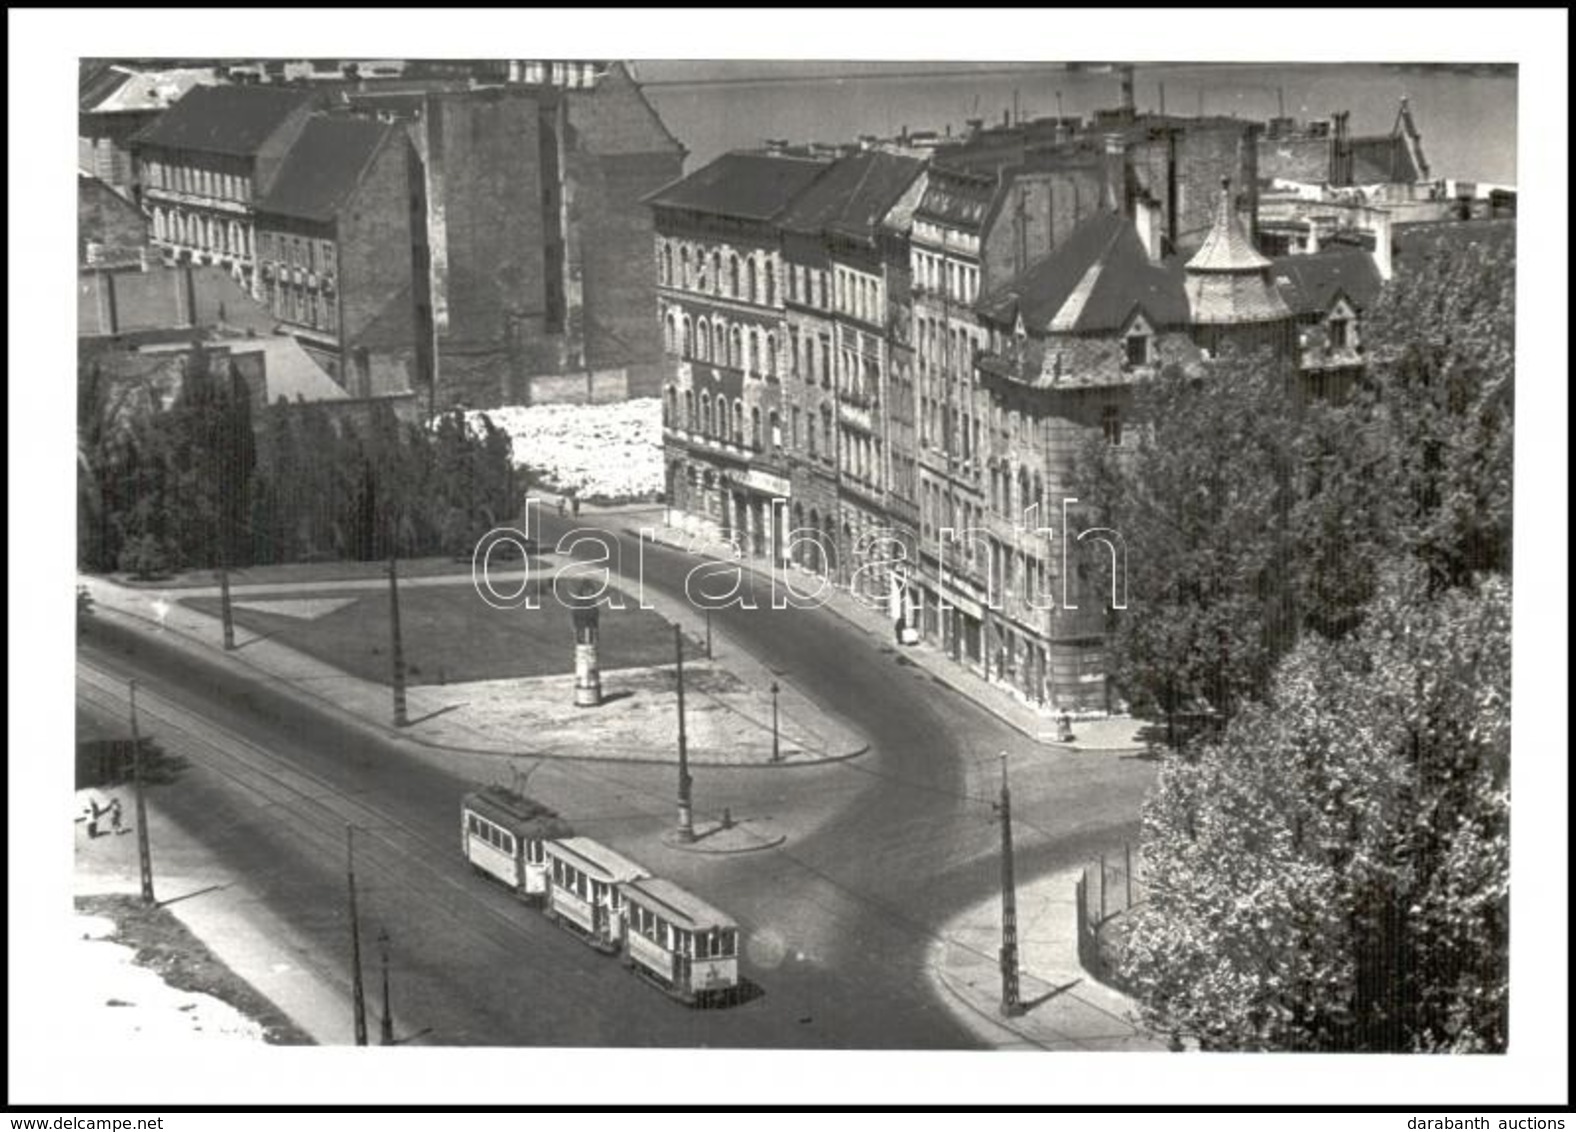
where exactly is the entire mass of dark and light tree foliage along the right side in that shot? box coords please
[1083,227,1515,1052]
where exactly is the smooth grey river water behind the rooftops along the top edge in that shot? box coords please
[635,60,1516,184]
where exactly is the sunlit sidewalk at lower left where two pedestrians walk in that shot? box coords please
[72,787,351,1044]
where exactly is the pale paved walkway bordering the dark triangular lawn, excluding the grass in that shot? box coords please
[79,557,867,766]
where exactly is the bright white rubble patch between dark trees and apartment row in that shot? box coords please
[468,397,662,501]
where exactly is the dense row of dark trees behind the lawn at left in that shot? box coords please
[77,350,520,577]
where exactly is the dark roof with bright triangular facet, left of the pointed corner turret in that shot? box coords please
[979,211,1188,334]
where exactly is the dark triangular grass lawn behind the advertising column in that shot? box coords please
[184,580,673,686]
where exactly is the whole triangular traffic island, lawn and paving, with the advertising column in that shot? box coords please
[82,560,865,768]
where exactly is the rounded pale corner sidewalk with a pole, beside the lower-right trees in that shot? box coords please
[927,869,1166,1052]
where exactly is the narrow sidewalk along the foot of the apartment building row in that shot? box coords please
[597,508,1149,754]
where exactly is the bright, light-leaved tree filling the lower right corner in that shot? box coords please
[1122,560,1510,1052]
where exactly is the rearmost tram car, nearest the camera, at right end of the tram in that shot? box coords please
[623,877,739,1006]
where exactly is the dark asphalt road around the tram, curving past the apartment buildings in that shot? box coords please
[79,522,1152,1048]
